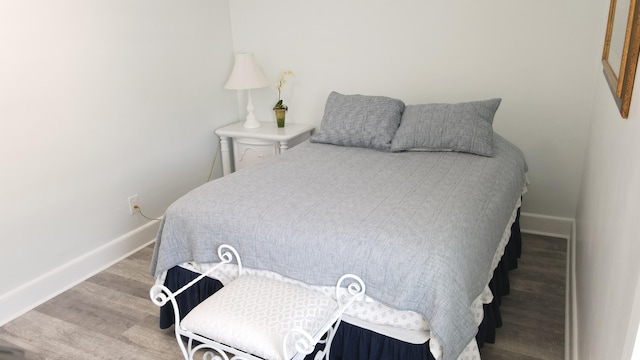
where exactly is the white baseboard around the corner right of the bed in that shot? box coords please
[520,212,577,360]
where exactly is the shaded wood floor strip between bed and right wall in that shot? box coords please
[480,234,567,360]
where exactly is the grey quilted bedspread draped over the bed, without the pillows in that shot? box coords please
[151,134,526,360]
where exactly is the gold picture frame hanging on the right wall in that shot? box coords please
[602,0,640,119]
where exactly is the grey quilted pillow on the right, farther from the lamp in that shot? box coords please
[391,99,502,156]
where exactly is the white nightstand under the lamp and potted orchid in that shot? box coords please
[215,122,314,175]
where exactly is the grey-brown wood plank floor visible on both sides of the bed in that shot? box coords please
[0,235,566,360]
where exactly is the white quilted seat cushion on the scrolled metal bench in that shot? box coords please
[181,275,338,360]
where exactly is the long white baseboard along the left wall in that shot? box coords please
[0,221,159,326]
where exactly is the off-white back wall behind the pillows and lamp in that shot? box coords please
[230,0,606,218]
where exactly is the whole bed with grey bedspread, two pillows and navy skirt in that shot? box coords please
[151,93,527,360]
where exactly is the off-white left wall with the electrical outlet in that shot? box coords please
[0,0,237,320]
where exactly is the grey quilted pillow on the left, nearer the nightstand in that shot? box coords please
[311,92,404,151]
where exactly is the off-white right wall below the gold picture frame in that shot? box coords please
[575,31,640,359]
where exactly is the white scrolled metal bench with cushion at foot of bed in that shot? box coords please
[150,245,365,360]
